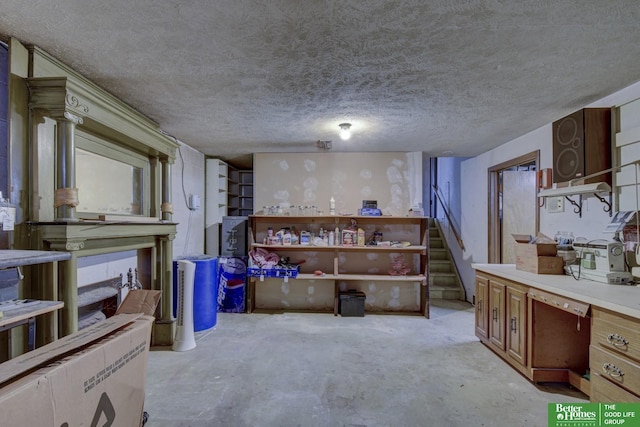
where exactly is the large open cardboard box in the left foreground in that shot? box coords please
[0,290,158,427]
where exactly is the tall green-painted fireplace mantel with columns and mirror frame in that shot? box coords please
[12,43,179,345]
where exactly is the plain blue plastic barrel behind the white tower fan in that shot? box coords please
[173,255,218,332]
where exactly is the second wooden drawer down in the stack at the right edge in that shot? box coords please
[589,345,640,394]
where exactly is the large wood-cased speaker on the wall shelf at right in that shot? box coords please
[552,108,611,184]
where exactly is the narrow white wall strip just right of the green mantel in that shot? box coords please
[171,143,205,259]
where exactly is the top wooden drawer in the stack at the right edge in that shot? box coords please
[591,310,640,361]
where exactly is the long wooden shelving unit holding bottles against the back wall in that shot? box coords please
[247,215,429,317]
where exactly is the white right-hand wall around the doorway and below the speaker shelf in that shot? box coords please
[456,82,640,299]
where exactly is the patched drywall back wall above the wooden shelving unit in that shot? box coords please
[253,152,423,216]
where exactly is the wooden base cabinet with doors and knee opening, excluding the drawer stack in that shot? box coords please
[475,273,590,394]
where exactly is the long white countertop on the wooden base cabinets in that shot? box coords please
[472,264,640,319]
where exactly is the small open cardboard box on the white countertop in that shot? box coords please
[514,235,564,274]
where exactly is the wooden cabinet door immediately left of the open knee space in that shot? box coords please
[506,286,527,366]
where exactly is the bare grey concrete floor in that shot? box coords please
[145,300,588,427]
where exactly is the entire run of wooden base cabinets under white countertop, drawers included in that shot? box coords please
[475,272,640,403]
